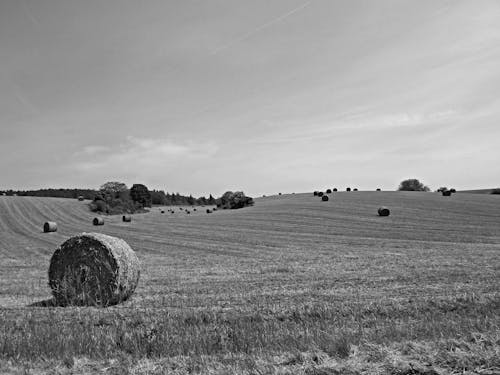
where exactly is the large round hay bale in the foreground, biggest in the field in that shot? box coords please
[49,233,140,306]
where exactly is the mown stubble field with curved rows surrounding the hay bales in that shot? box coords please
[0,192,500,375]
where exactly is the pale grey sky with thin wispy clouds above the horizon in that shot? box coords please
[0,0,500,196]
